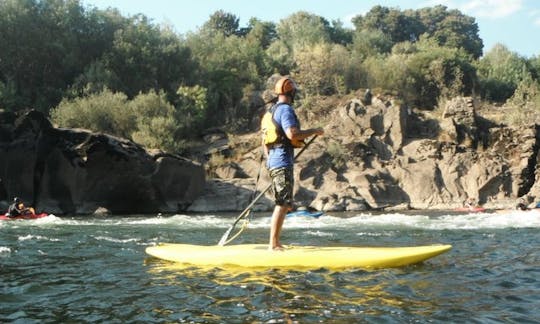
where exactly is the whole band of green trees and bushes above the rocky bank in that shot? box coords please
[0,0,540,152]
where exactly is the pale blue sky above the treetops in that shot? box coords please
[82,0,540,58]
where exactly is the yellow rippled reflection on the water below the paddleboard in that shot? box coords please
[146,259,436,322]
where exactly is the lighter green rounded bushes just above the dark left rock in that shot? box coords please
[51,86,202,152]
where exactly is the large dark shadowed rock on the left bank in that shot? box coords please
[0,111,205,214]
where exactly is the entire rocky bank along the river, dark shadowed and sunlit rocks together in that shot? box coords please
[0,96,540,214]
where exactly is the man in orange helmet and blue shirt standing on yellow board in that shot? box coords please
[261,77,324,250]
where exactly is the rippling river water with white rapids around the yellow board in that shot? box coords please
[0,211,540,323]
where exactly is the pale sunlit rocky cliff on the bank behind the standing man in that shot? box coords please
[188,96,540,212]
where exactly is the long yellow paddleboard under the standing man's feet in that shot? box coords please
[146,243,452,269]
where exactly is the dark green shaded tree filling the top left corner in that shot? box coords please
[0,0,116,111]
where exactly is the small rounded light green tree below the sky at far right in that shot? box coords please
[477,44,531,101]
